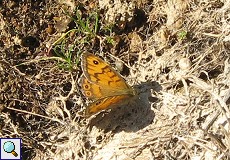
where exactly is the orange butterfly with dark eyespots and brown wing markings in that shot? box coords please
[80,52,136,116]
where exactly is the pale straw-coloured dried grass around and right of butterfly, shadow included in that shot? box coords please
[0,0,230,160]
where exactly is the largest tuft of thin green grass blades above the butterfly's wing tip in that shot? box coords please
[52,9,99,69]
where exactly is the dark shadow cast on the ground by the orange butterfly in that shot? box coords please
[89,82,162,133]
